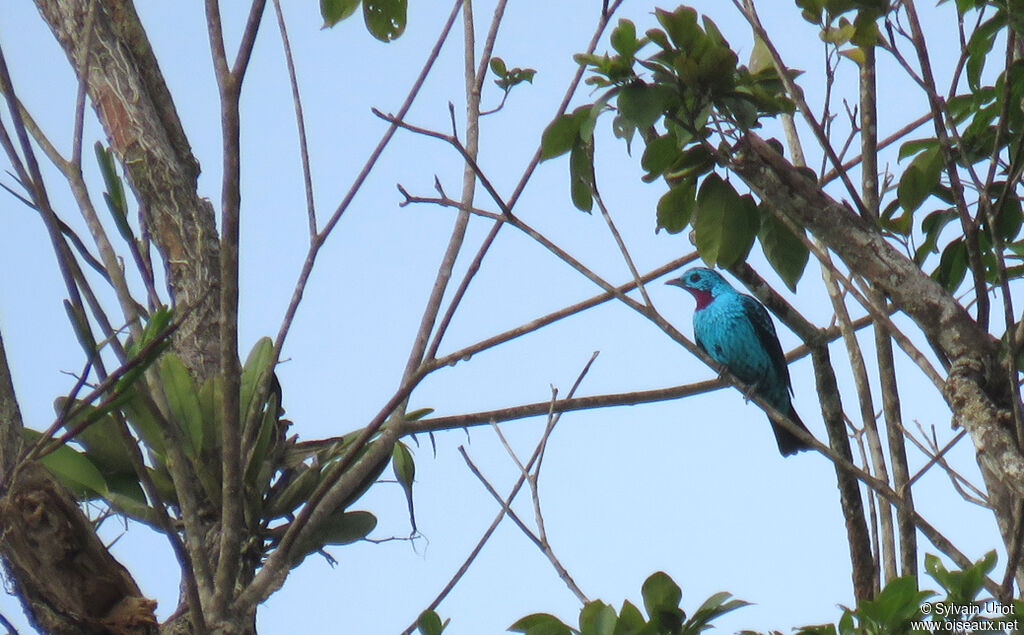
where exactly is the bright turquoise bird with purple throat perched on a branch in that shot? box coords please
[666,267,810,457]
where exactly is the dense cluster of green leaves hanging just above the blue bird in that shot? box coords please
[541,6,808,288]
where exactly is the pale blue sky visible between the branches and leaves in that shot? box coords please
[0,0,998,635]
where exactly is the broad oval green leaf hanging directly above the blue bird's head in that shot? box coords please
[693,173,759,268]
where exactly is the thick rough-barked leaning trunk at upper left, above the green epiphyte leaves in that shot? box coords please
[36,0,220,381]
